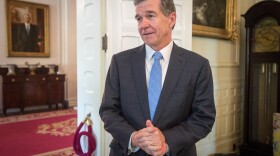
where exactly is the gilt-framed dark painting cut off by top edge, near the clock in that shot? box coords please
[192,0,237,40]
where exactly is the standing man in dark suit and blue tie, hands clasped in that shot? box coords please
[99,0,216,156]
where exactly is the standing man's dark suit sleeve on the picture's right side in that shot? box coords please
[163,61,216,156]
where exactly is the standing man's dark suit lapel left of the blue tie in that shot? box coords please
[131,45,150,119]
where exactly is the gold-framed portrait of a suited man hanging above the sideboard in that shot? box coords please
[6,0,50,57]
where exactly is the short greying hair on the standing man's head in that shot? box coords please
[134,0,176,16]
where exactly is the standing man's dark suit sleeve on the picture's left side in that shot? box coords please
[99,55,135,155]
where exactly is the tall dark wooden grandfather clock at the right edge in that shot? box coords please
[240,0,280,156]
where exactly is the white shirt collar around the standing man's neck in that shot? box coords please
[145,41,173,62]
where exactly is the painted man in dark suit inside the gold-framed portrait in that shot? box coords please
[17,14,39,52]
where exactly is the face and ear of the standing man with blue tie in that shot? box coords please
[135,0,176,50]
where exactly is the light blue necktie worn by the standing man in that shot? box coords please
[148,52,162,120]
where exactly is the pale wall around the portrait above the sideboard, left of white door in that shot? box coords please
[0,0,77,110]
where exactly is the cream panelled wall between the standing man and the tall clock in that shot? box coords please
[192,0,260,155]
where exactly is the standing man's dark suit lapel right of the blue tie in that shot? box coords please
[153,43,185,124]
